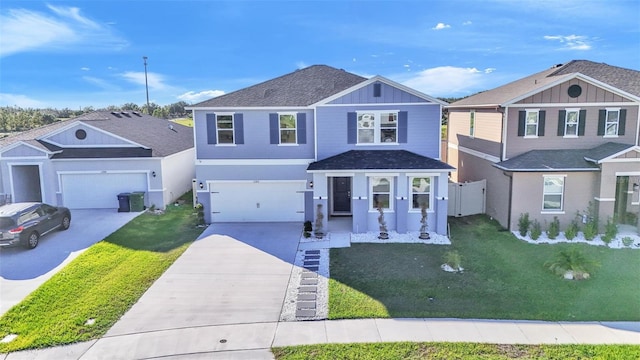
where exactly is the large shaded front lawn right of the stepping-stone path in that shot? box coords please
[329,216,640,321]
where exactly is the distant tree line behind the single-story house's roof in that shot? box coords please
[0,101,189,133]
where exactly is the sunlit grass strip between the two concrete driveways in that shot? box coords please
[0,194,202,353]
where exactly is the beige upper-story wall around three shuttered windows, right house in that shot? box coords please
[506,106,638,158]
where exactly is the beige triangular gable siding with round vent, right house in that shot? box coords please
[517,79,631,104]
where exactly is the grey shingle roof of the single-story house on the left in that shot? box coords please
[0,111,194,157]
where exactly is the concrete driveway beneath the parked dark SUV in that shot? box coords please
[0,209,142,315]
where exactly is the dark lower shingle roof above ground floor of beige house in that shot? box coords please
[494,143,633,172]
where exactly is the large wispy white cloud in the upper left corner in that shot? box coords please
[0,5,127,57]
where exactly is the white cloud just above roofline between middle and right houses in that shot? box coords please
[402,66,495,97]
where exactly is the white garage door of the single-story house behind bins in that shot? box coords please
[62,173,147,209]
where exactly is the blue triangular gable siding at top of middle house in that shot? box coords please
[329,82,427,104]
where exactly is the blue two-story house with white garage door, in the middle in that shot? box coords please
[189,65,453,234]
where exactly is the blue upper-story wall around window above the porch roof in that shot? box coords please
[316,104,440,160]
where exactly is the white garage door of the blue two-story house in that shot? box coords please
[211,181,305,222]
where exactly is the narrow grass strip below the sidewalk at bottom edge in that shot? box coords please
[272,342,640,360]
